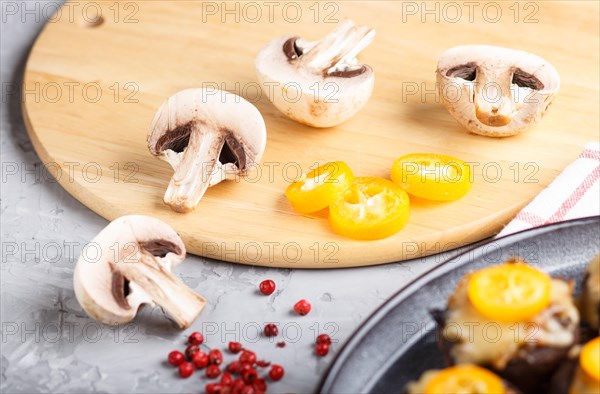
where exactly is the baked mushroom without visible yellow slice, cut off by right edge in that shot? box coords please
[579,255,600,335]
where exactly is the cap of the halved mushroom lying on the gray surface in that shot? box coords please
[73,215,186,324]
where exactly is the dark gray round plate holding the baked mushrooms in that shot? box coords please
[318,217,600,394]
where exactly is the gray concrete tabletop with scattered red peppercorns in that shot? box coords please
[0,3,464,393]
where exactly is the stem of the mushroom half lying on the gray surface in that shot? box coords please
[116,250,206,329]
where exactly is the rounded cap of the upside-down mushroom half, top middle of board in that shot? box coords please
[255,36,375,127]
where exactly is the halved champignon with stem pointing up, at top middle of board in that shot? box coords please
[255,20,375,127]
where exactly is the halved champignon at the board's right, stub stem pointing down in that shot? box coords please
[437,45,560,137]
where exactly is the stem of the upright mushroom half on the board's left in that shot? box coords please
[164,121,224,212]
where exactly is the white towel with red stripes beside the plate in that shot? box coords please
[498,142,600,237]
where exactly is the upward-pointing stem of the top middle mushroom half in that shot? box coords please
[300,19,375,72]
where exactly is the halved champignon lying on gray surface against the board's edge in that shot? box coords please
[73,215,206,328]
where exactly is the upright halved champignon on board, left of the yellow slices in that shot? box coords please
[148,89,267,212]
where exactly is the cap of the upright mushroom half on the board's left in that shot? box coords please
[148,88,267,167]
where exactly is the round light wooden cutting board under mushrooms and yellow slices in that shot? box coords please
[23,0,600,268]
